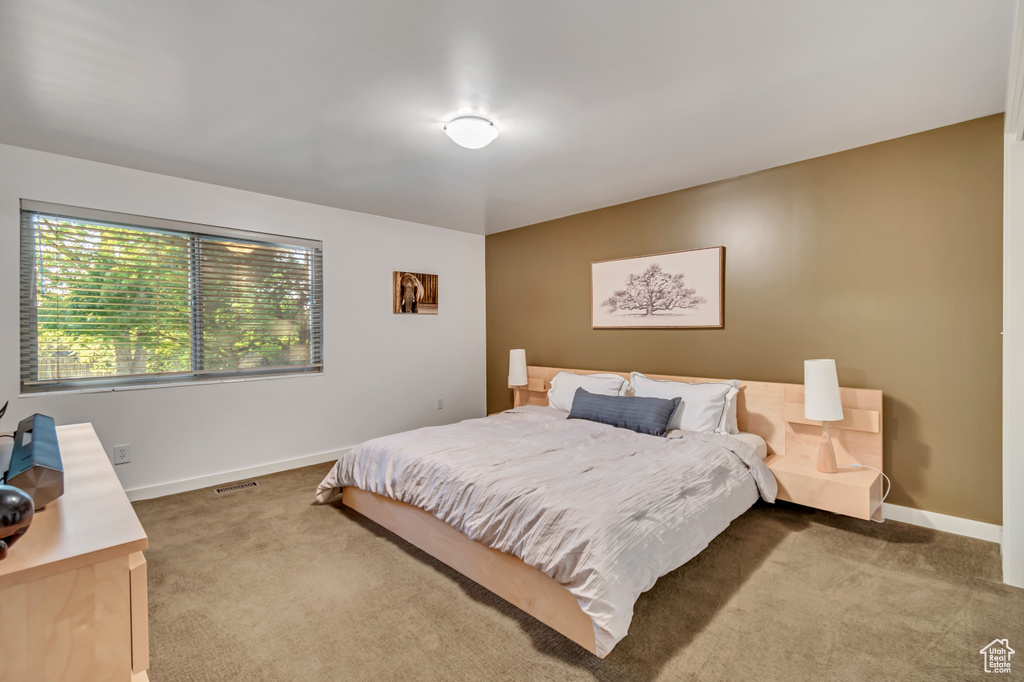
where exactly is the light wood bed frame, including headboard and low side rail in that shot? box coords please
[342,367,882,654]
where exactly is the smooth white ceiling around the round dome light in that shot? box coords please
[0,0,1016,233]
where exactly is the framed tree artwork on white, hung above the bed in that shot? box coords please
[591,247,725,329]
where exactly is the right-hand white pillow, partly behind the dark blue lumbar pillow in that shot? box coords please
[630,372,739,434]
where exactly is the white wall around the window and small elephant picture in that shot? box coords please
[0,144,485,495]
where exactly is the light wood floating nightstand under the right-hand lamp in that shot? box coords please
[765,455,883,521]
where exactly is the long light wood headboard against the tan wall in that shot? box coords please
[514,366,882,469]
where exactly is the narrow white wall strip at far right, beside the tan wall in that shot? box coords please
[1002,134,1024,587]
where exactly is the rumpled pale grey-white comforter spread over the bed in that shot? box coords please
[316,409,776,656]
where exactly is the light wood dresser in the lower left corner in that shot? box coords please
[0,424,150,682]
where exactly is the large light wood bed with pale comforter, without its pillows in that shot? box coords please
[317,367,884,657]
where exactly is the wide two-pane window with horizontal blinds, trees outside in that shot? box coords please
[22,200,323,392]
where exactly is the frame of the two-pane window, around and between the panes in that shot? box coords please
[18,199,324,395]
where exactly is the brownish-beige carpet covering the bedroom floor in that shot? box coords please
[135,464,1024,682]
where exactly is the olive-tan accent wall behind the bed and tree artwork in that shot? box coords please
[486,115,1002,523]
